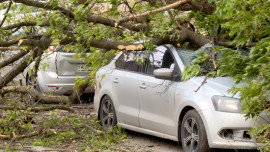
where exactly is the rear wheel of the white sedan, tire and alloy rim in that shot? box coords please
[99,96,117,131]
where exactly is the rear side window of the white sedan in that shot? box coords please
[115,51,147,73]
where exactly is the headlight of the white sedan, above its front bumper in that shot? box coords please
[212,96,241,113]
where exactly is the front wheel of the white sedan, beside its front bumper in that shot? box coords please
[181,110,211,152]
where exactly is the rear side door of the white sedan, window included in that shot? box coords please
[112,51,148,127]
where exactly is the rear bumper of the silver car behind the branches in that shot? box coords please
[37,71,94,95]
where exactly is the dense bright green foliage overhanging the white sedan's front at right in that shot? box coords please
[190,0,270,151]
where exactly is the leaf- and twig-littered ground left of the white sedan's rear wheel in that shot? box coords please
[0,94,126,151]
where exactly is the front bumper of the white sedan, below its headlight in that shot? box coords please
[199,111,265,149]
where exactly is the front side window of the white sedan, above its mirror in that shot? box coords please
[146,46,175,75]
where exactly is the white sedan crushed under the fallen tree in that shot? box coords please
[94,45,262,152]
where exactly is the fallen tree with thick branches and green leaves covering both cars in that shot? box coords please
[0,0,270,150]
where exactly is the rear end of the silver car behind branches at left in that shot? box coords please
[37,52,94,94]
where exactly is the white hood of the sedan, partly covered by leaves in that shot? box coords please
[191,77,244,98]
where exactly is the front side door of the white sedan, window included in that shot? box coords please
[139,46,180,135]
